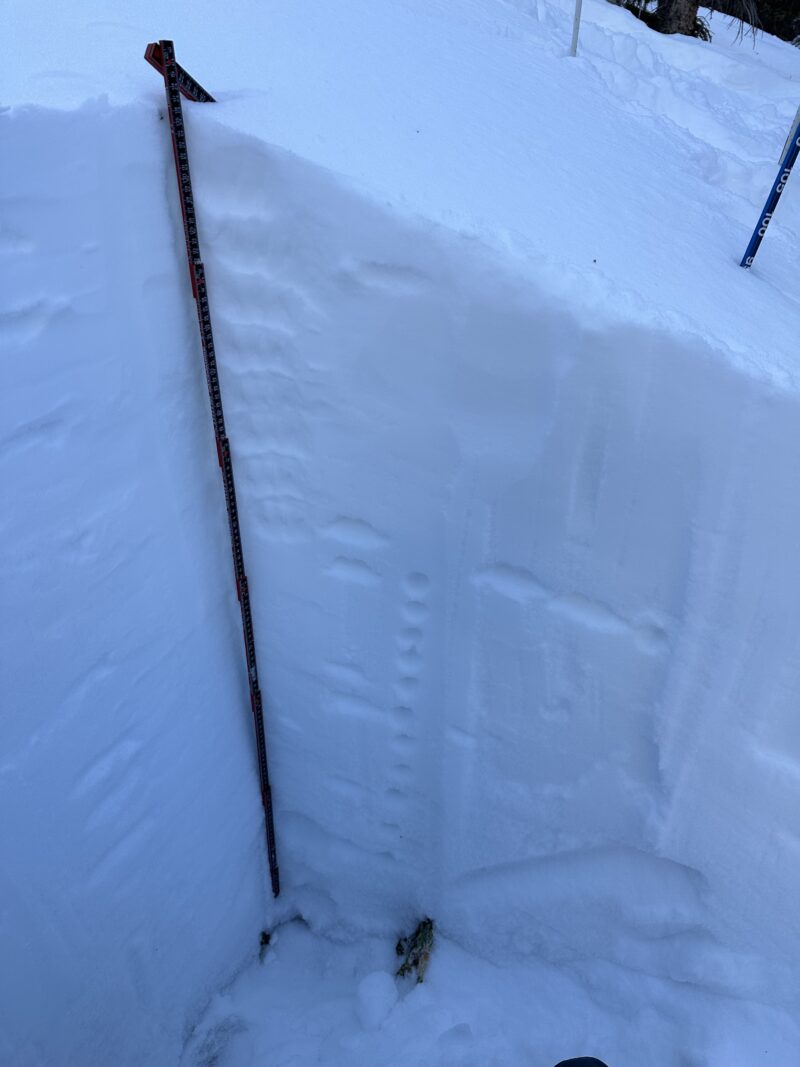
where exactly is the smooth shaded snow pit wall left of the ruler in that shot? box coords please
[0,106,275,1067]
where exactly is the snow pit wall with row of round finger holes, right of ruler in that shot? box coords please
[190,122,800,1003]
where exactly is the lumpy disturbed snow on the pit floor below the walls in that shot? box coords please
[181,922,800,1067]
